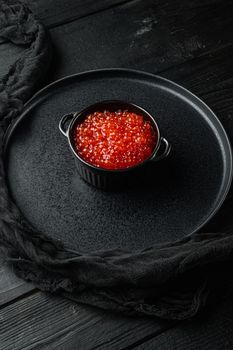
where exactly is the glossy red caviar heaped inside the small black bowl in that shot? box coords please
[74,110,156,169]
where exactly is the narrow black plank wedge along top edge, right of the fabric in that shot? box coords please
[28,0,134,28]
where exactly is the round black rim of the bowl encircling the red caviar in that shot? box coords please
[66,100,161,173]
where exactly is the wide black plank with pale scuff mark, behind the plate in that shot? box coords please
[45,0,233,81]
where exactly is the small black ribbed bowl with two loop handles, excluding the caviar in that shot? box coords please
[59,101,171,190]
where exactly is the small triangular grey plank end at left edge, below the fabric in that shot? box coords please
[0,254,35,307]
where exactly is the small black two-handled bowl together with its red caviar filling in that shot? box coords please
[59,101,171,189]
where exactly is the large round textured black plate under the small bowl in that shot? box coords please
[3,69,232,251]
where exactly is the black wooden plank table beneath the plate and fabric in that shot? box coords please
[0,0,233,350]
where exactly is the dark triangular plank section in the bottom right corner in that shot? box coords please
[134,300,233,350]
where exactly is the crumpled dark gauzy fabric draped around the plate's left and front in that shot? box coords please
[0,0,233,320]
